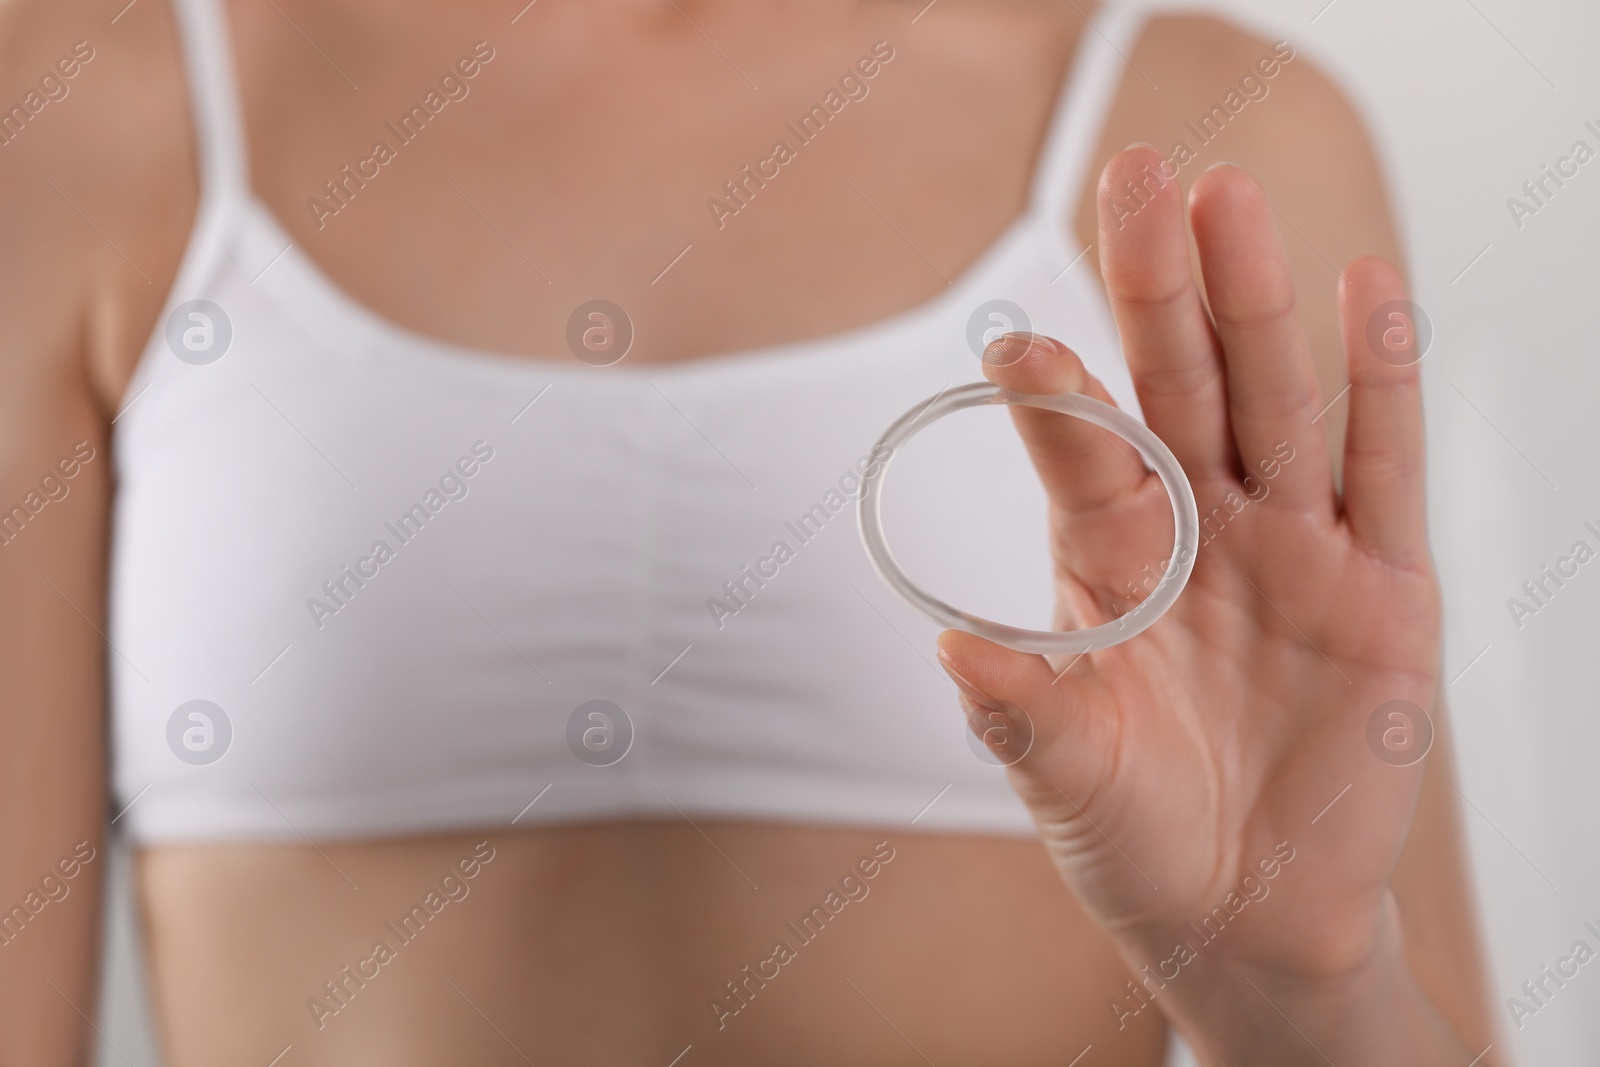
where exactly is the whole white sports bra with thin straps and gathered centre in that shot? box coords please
[109,0,1139,843]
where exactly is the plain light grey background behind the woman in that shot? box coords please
[98,0,1600,1067]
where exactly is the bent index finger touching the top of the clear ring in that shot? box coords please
[984,333,1147,514]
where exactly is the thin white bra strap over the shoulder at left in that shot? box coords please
[173,0,250,198]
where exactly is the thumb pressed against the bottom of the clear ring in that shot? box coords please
[938,630,1117,812]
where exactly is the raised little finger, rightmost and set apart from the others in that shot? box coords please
[1339,256,1427,565]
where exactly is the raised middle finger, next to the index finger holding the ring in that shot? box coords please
[1099,147,1235,480]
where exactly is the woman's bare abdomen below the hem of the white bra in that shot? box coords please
[139,821,1165,1067]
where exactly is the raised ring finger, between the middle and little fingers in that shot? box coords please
[1190,166,1334,520]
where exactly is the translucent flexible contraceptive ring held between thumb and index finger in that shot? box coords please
[858,382,1200,656]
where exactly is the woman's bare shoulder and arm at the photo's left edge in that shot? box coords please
[0,2,194,1067]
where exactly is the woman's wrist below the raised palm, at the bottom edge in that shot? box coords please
[1128,901,1472,1067]
